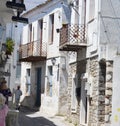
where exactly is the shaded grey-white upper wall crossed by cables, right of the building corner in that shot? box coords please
[100,0,120,60]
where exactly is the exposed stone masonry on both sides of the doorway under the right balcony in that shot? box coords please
[68,57,113,126]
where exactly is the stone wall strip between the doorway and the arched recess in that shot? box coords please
[88,57,99,126]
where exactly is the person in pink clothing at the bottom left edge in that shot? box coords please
[0,93,9,126]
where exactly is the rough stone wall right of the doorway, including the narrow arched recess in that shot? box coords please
[88,58,113,126]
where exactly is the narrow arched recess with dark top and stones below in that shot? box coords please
[98,59,106,126]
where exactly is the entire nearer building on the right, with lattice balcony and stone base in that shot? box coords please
[60,0,120,126]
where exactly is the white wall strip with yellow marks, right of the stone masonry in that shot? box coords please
[111,55,120,126]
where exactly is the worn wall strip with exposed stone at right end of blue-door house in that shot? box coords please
[56,56,68,115]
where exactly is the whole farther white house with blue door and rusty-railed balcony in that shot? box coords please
[20,0,70,115]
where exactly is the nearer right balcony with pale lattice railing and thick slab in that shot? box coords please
[59,24,87,51]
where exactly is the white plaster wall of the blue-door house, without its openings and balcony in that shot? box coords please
[21,0,69,114]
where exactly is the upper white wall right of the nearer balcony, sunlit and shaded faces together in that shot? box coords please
[86,0,120,60]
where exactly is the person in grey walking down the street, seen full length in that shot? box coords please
[15,86,22,110]
